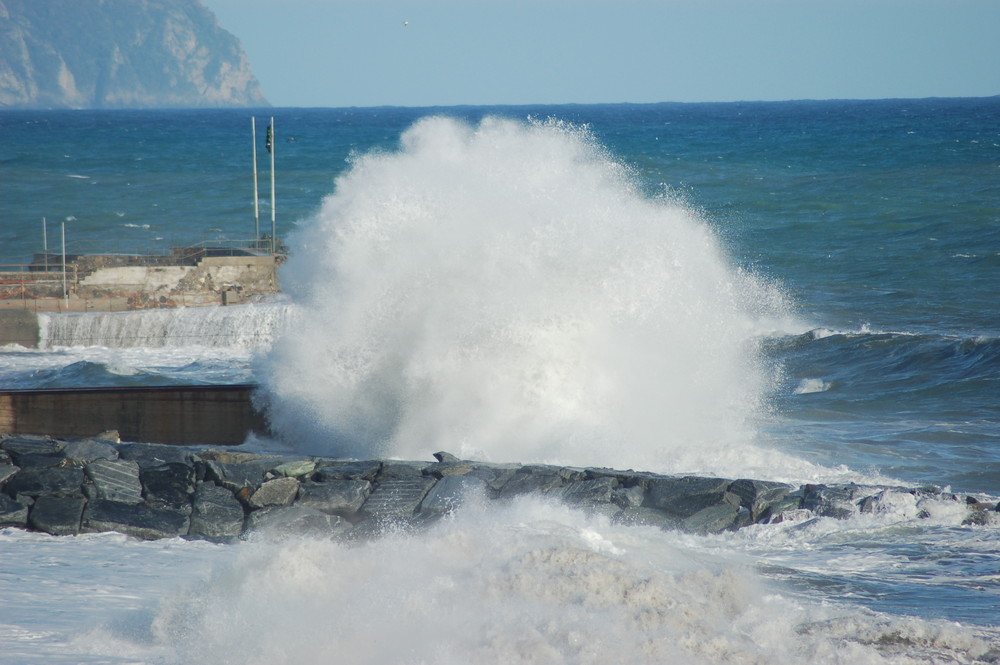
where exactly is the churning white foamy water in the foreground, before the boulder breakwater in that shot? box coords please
[0,499,995,665]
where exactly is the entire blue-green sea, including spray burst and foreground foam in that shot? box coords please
[0,97,1000,665]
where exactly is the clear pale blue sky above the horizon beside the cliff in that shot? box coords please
[202,0,1000,107]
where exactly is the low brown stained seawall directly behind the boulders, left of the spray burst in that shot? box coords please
[0,385,265,445]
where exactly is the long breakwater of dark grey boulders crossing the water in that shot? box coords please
[0,434,1000,542]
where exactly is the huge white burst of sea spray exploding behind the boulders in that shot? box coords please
[257,117,796,472]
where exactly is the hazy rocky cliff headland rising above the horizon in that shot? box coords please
[0,0,267,109]
